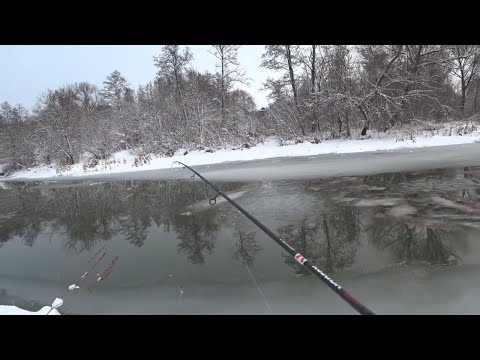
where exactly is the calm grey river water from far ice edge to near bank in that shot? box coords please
[0,167,480,314]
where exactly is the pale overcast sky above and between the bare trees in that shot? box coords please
[0,45,271,108]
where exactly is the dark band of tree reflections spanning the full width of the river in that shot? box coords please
[0,168,480,274]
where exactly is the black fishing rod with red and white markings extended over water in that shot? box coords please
[173,161,375,315]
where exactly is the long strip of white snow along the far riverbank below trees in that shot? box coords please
[0,130,480,183]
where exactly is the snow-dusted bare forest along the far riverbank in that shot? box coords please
[0,45,480,174]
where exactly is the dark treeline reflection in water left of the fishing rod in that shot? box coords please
[0,181,239,253]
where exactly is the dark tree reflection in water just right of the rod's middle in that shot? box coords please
[279,206,360,274]
